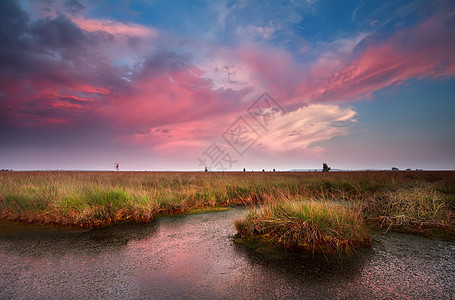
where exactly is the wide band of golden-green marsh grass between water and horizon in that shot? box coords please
[0,171,455,229]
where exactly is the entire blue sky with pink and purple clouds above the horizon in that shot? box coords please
[0,0,455,171]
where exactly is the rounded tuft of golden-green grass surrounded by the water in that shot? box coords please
[235,200,371,254]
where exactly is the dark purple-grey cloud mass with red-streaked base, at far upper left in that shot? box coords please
[0,1,127,126]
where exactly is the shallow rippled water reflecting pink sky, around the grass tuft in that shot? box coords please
[0,209,455,299]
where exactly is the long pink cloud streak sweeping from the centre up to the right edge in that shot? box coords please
[230,13,455,105]
